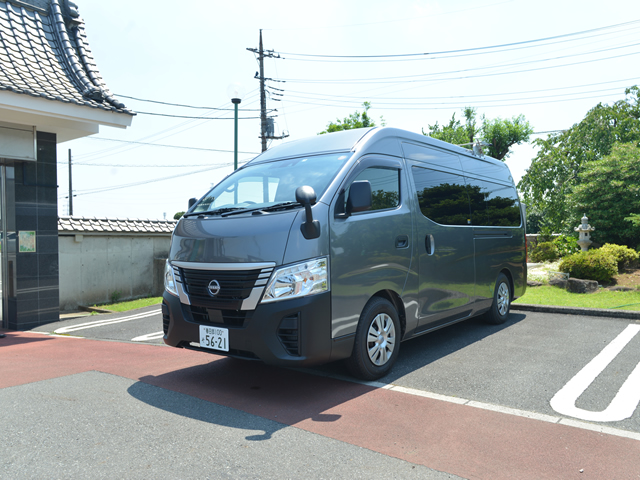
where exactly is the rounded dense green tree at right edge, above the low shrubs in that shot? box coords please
[569,143,640,248]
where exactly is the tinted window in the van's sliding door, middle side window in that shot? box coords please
[411,167,471,225]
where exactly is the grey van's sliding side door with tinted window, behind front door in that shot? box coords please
[411,165,475,330]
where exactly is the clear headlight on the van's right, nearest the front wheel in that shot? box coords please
[262,257,329,303]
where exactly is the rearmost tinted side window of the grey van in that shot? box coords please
[467,177,520,227]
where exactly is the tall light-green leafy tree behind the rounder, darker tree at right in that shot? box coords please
[518,86,640,232]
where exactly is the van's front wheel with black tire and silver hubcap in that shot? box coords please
[346,297,401,380]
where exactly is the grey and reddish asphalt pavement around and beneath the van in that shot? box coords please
[0,307,640,480]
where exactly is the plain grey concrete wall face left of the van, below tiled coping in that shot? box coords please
[58,234,171,311]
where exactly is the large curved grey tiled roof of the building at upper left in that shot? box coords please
[0,0,134,115]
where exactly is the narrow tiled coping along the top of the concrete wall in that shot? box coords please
[58,217,178,235]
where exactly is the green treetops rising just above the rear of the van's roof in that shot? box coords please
[422,107,533,161]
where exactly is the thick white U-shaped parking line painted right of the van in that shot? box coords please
[551,324,640,422]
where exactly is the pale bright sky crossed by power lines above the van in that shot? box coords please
[58,0,640,219]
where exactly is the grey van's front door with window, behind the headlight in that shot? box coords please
[329,157,412,338]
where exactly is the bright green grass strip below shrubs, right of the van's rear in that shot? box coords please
[514,285,640,311]
